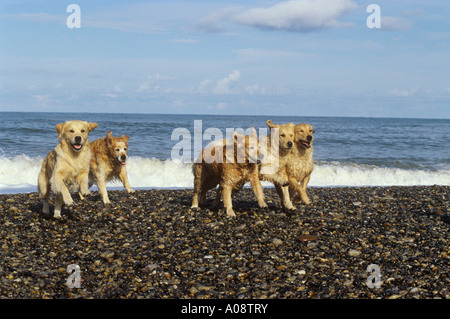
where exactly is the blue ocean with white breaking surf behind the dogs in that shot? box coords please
[0,112,450,193]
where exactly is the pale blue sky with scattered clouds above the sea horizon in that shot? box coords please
[0,0,450,119]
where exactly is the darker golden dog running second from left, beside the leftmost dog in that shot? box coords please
[80,131,134,204]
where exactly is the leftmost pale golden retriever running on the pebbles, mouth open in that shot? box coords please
[38,120,98,218]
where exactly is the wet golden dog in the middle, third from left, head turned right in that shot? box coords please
[191,127,267,217]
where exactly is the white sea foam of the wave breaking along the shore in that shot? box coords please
[0,155,450,193]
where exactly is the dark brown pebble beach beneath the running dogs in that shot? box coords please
[0,186,450,299]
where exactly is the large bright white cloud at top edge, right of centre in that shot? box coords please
[233,0,358,32]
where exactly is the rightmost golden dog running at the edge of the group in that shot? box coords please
[286,124,314,204]
